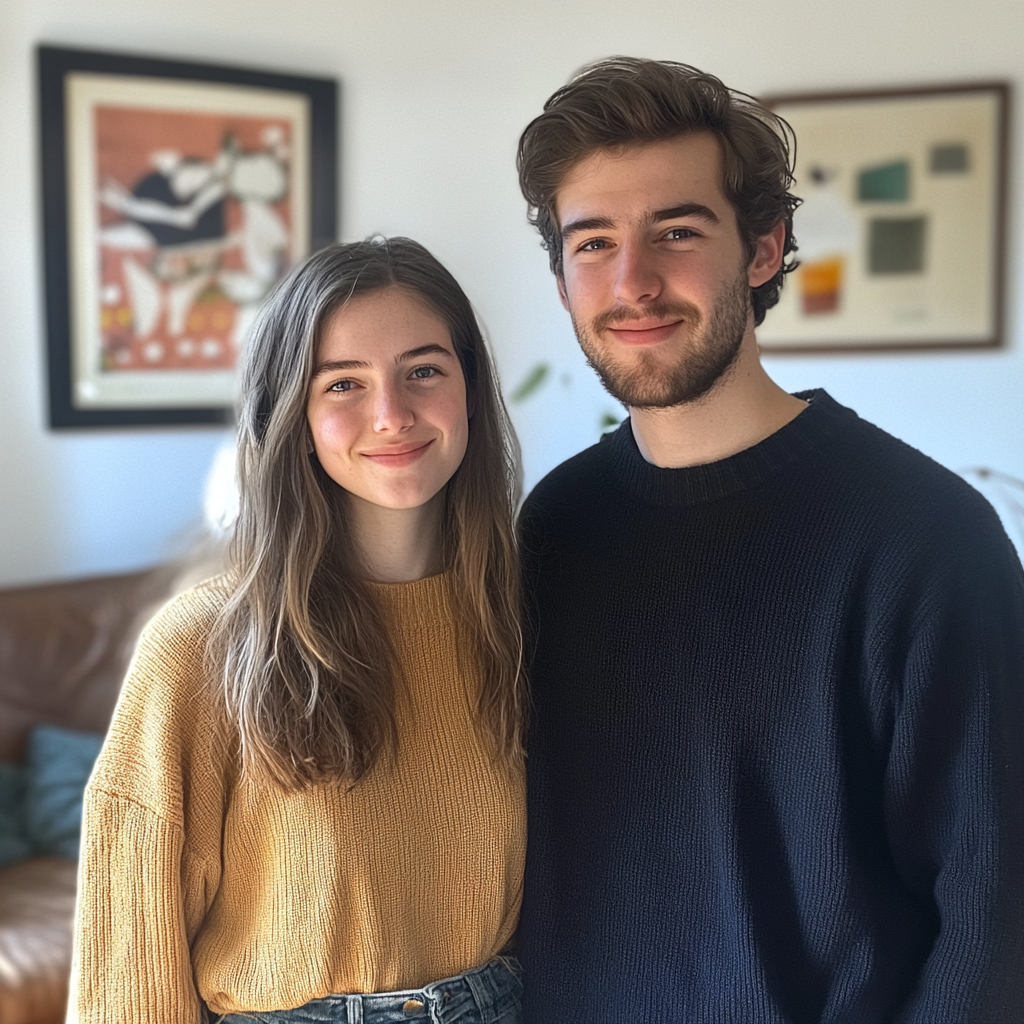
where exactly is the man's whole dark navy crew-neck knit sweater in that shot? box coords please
[519,391,1024,1024]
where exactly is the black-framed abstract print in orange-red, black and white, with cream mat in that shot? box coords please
[38,46,338,427]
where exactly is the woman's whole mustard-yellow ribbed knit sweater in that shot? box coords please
[71,574,525,1024]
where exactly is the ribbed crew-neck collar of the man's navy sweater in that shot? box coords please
[604,388,857,505]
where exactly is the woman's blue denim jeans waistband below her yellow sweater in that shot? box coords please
[215,961,522,1024]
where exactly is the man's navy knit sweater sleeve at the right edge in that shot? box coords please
[886,510,1024,1024]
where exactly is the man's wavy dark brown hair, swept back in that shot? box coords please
[517,56,800,324]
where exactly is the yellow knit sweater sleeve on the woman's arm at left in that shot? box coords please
[69,587,226,1024]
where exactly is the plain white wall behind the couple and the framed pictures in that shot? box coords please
[0,0,1024,584]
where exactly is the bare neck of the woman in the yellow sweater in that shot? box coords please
[348,494,444,583]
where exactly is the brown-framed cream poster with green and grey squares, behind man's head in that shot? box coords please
[758,83,1010,352]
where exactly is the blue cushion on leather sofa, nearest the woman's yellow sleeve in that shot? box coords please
[25,725,103,858]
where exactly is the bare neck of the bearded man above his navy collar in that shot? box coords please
[630,333,807,469]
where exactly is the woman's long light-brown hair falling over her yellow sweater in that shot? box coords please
[207,237,525,790]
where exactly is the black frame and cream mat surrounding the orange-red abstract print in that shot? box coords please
[37,45,339,429]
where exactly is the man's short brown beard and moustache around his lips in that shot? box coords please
[570,269,751,409]
